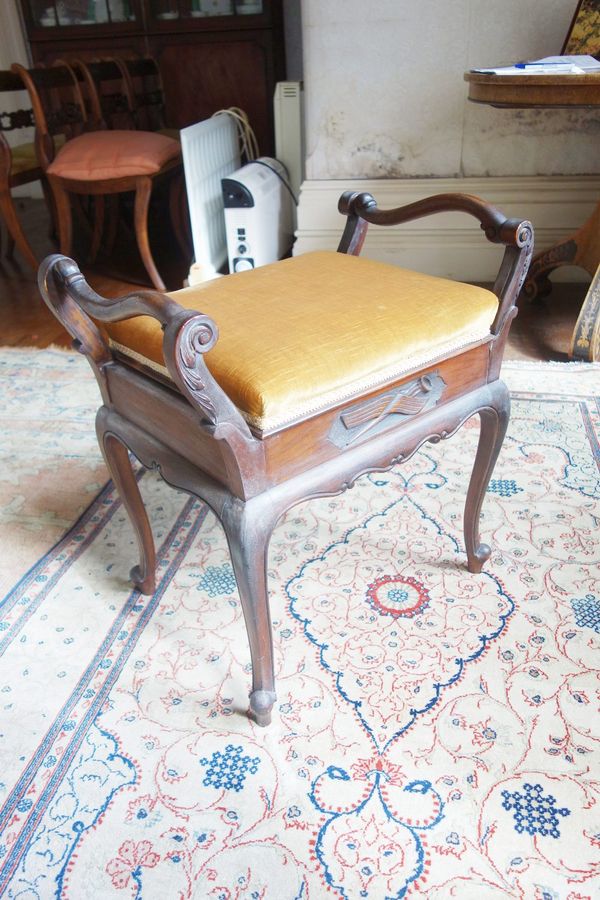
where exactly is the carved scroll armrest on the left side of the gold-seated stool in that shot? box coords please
[38,254,256,443]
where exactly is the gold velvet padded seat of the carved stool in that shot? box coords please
[106,251,498,432]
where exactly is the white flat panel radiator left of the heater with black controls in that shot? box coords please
[181,115,240,284]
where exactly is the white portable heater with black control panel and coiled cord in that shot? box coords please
[221,156,294,272]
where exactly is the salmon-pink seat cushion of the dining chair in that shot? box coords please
[48,130,181,181]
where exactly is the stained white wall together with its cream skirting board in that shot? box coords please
[294,0,600,281]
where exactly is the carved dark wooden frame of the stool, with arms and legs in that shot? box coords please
[39,193,533,725]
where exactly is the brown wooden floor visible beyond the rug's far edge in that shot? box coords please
[0,200,587,361]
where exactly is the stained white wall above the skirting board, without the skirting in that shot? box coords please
[302,0,600,179]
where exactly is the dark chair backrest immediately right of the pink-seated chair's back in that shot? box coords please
[70,59,136,129]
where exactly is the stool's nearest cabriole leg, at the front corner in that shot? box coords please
[221,499,277,726]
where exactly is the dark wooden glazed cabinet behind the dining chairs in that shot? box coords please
[20,0,285,153]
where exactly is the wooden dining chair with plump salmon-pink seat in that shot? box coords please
[12,63,182,290]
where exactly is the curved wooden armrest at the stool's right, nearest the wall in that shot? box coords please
[338,191,533,334]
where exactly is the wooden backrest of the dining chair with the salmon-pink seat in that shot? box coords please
[11,63,88,171]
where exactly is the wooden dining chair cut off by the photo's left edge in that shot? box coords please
[0,71,42,271]
